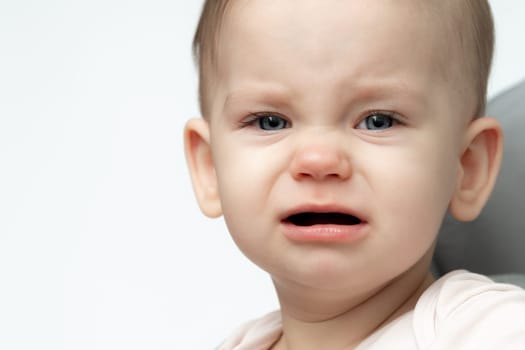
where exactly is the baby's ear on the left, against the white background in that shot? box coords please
[184,119,222,217]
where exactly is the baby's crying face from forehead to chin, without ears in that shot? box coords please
[205,0,467,290]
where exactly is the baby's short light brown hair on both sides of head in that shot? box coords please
[193,0,494,118]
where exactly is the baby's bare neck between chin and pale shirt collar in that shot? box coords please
[272,258,434,350]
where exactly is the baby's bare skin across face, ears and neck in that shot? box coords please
[185,0,502,350]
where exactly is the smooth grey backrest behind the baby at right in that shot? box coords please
[433,81,525,287]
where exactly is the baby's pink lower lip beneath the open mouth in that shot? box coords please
[283,222,366,242]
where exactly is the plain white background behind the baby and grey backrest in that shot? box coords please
[0,0,525,350]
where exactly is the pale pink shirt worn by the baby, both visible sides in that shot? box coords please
[219,271,525,350]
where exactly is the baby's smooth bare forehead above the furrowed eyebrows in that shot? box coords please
[219,0,450,101]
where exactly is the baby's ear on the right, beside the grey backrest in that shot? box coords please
[450,117,503,221]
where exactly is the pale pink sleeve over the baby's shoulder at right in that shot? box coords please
[413,271,525,349]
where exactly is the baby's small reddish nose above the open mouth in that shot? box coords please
[290,140,352,181]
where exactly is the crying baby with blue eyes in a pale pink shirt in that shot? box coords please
[185,0,525,350]
